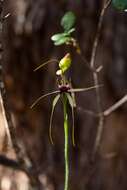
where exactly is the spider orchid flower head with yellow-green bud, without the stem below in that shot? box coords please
[31,53,100,146]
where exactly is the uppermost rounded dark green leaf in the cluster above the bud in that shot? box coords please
[61,11,76,31]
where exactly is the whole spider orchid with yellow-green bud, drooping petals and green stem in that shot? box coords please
[31,53,101,190]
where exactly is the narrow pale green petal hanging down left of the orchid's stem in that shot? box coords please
[49,94,60,144]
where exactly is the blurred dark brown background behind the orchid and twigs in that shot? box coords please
[0,0,127,190]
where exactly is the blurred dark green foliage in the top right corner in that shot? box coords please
[112,0,127,11]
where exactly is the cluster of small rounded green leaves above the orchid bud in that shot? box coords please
[51,11,76,46]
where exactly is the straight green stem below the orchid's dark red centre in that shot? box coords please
[63,94,69,190]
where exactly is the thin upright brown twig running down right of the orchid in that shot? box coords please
[90,0,111,155]
